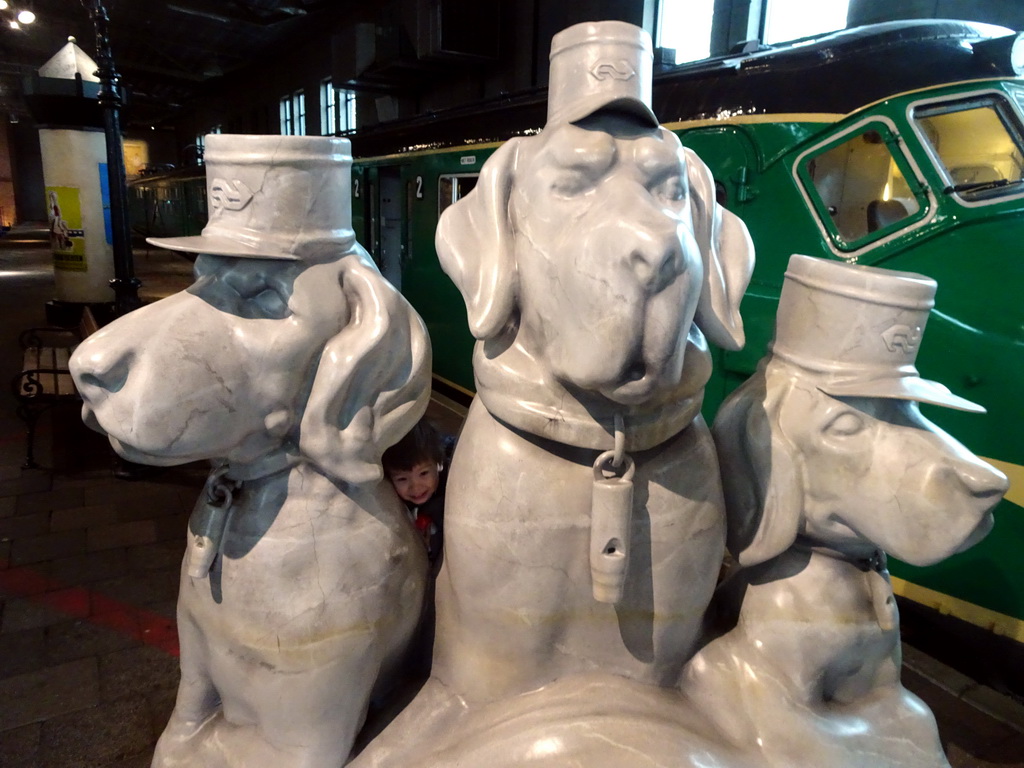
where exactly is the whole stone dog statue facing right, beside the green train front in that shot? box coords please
[683,255,1007,768]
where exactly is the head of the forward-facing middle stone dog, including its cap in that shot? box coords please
[436,23,753,404]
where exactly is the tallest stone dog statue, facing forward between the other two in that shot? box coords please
[353,22,753,768]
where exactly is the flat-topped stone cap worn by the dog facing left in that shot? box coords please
[147,134,355,261]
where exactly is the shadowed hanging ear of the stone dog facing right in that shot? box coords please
[712,361,804,566]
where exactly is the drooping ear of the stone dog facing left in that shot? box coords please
[299,249,430,484]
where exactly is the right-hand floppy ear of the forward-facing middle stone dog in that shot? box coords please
[683,147,754,349]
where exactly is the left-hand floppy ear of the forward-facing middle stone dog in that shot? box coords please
[434,138,522,339]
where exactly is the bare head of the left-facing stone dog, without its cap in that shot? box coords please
[72,247,429,482]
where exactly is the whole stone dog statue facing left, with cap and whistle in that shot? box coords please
[72,135,430,768]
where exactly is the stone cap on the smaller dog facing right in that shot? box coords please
[771,254,985,413]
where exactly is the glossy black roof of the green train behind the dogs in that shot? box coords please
[349,19,1024,158]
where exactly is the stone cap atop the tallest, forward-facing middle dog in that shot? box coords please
[548,22,657,126]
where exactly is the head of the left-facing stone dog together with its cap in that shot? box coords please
[71,136,430,483]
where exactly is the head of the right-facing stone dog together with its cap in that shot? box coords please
[713,256,1008,566]
